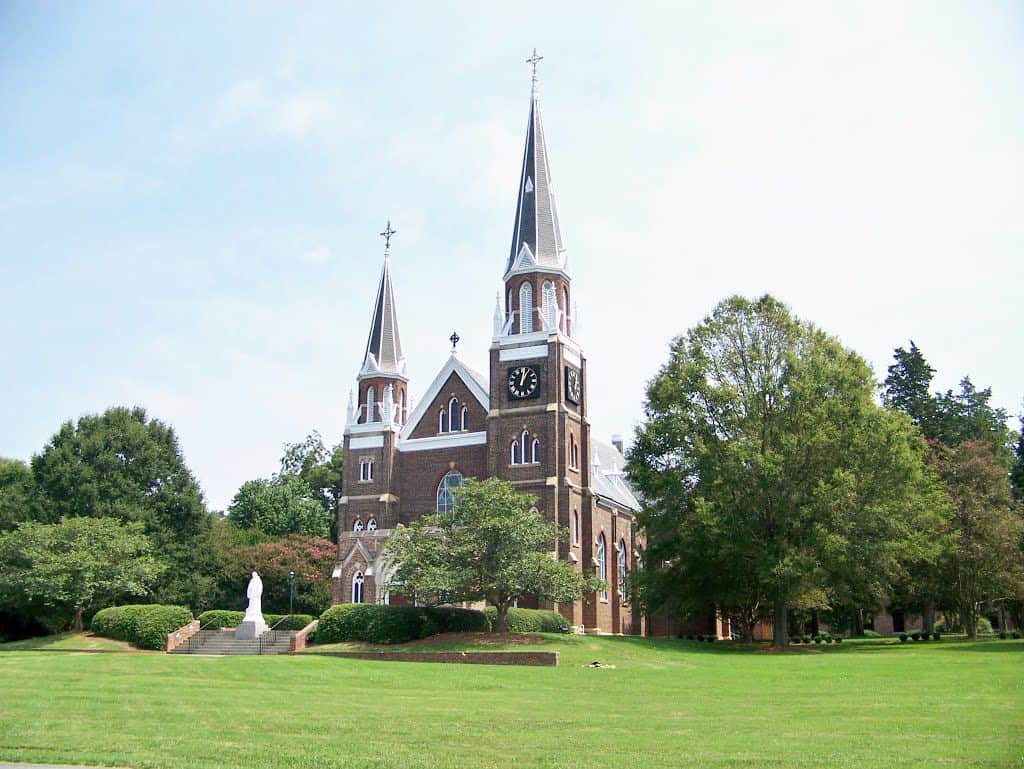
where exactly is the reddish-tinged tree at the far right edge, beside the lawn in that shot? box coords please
[934,440,1024,638]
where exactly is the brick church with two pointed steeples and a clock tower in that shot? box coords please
[332,57,644,634]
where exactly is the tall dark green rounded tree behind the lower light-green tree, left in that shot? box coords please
[31,407,213,606]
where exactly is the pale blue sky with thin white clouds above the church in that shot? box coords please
[0,0,1024,509]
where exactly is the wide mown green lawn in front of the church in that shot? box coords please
[0,636,1024,769]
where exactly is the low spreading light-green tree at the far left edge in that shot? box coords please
[0,517,162,631]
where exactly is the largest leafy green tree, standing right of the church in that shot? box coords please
[629,296,931,645]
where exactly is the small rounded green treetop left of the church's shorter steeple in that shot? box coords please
[227,474,333,538]
